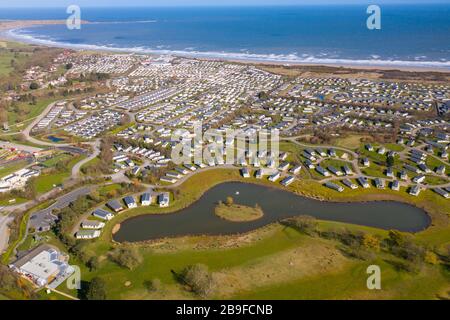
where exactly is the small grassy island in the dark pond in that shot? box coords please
[214,197,264,222]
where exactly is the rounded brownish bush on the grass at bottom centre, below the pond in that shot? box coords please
[181,264,213,297]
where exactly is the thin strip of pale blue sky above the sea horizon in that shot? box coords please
[0,0,450,7]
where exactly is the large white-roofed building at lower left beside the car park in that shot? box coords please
[9,244,75,287]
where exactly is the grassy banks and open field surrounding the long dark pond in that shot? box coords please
[35,166,442,299]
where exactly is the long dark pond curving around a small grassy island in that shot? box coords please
[114,182,431,242]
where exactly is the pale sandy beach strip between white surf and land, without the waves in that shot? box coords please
[0,20,450,73]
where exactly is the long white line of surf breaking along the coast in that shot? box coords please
[7,29,450,70]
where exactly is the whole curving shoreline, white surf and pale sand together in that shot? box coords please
[0,20,450,74]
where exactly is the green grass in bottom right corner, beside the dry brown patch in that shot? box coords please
[232,260,448,300]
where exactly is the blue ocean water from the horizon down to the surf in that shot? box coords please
[0,4,450,69]
